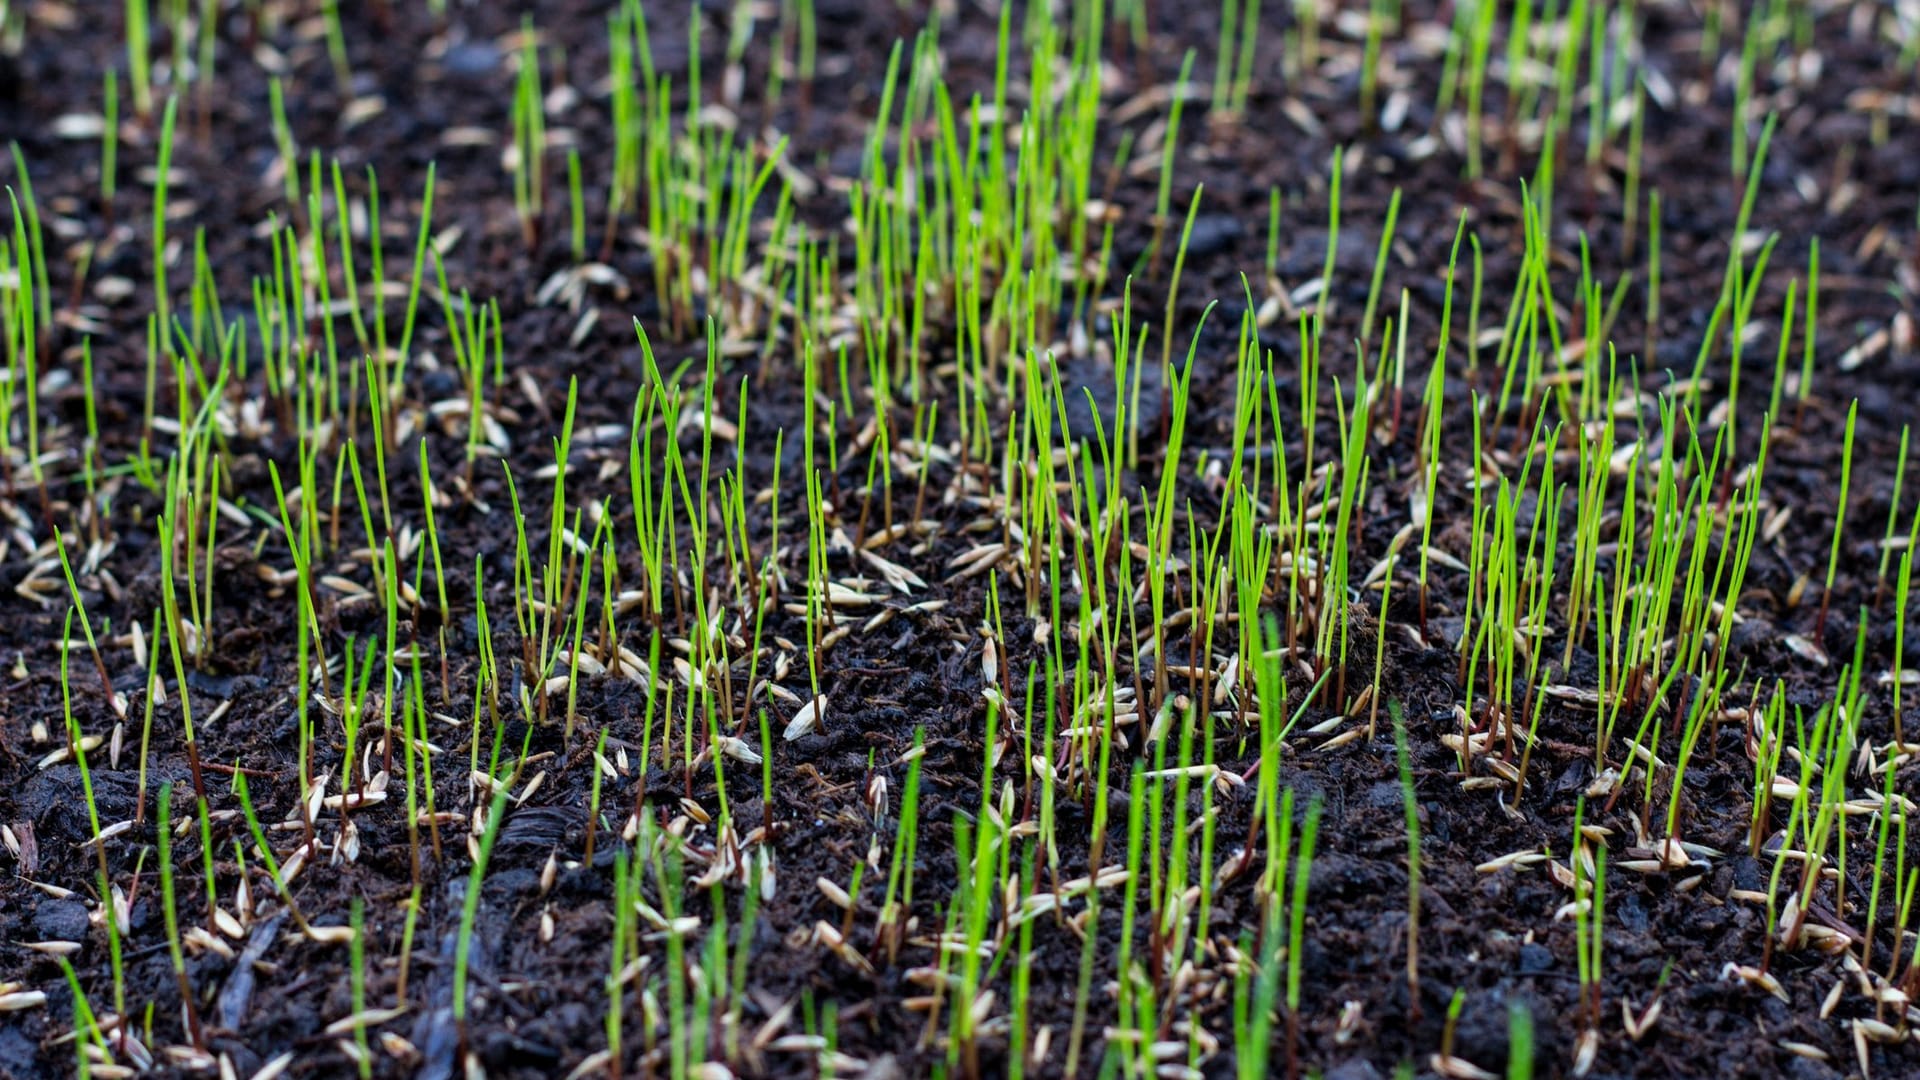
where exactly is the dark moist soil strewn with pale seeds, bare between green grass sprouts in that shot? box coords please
[0,0,1920,1080]
